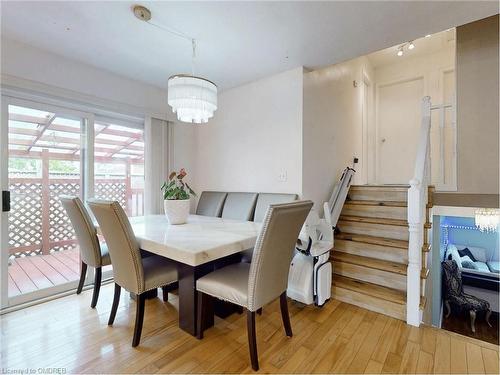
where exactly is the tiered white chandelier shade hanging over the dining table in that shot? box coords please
[168,74,217,124]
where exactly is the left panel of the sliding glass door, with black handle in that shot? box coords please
[1,97,92,305]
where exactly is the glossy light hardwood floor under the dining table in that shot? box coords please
[0,284,499,373]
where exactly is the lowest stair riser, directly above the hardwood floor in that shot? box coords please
[332,285,406,321]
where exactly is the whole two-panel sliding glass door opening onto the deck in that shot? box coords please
[0,96,144,308]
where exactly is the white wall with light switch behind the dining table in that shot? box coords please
[195,67,303,194]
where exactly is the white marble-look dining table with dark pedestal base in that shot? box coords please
[97,215,261,336]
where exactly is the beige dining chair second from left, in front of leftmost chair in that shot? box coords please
[88,199,177,347]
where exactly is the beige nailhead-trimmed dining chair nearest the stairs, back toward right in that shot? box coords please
[196,201,313,371]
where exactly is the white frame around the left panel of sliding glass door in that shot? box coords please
[0,94,94,309]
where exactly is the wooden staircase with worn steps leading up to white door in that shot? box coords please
[331,185,432,321]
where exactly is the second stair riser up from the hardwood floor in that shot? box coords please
[333,261,406,291]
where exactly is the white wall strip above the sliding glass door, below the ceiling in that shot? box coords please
[1,39,170,120]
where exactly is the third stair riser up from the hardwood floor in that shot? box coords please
[334,239,408,264]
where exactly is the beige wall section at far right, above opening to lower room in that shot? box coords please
[457,15,500,197]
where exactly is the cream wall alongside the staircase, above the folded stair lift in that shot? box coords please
[302,57,373,207]
